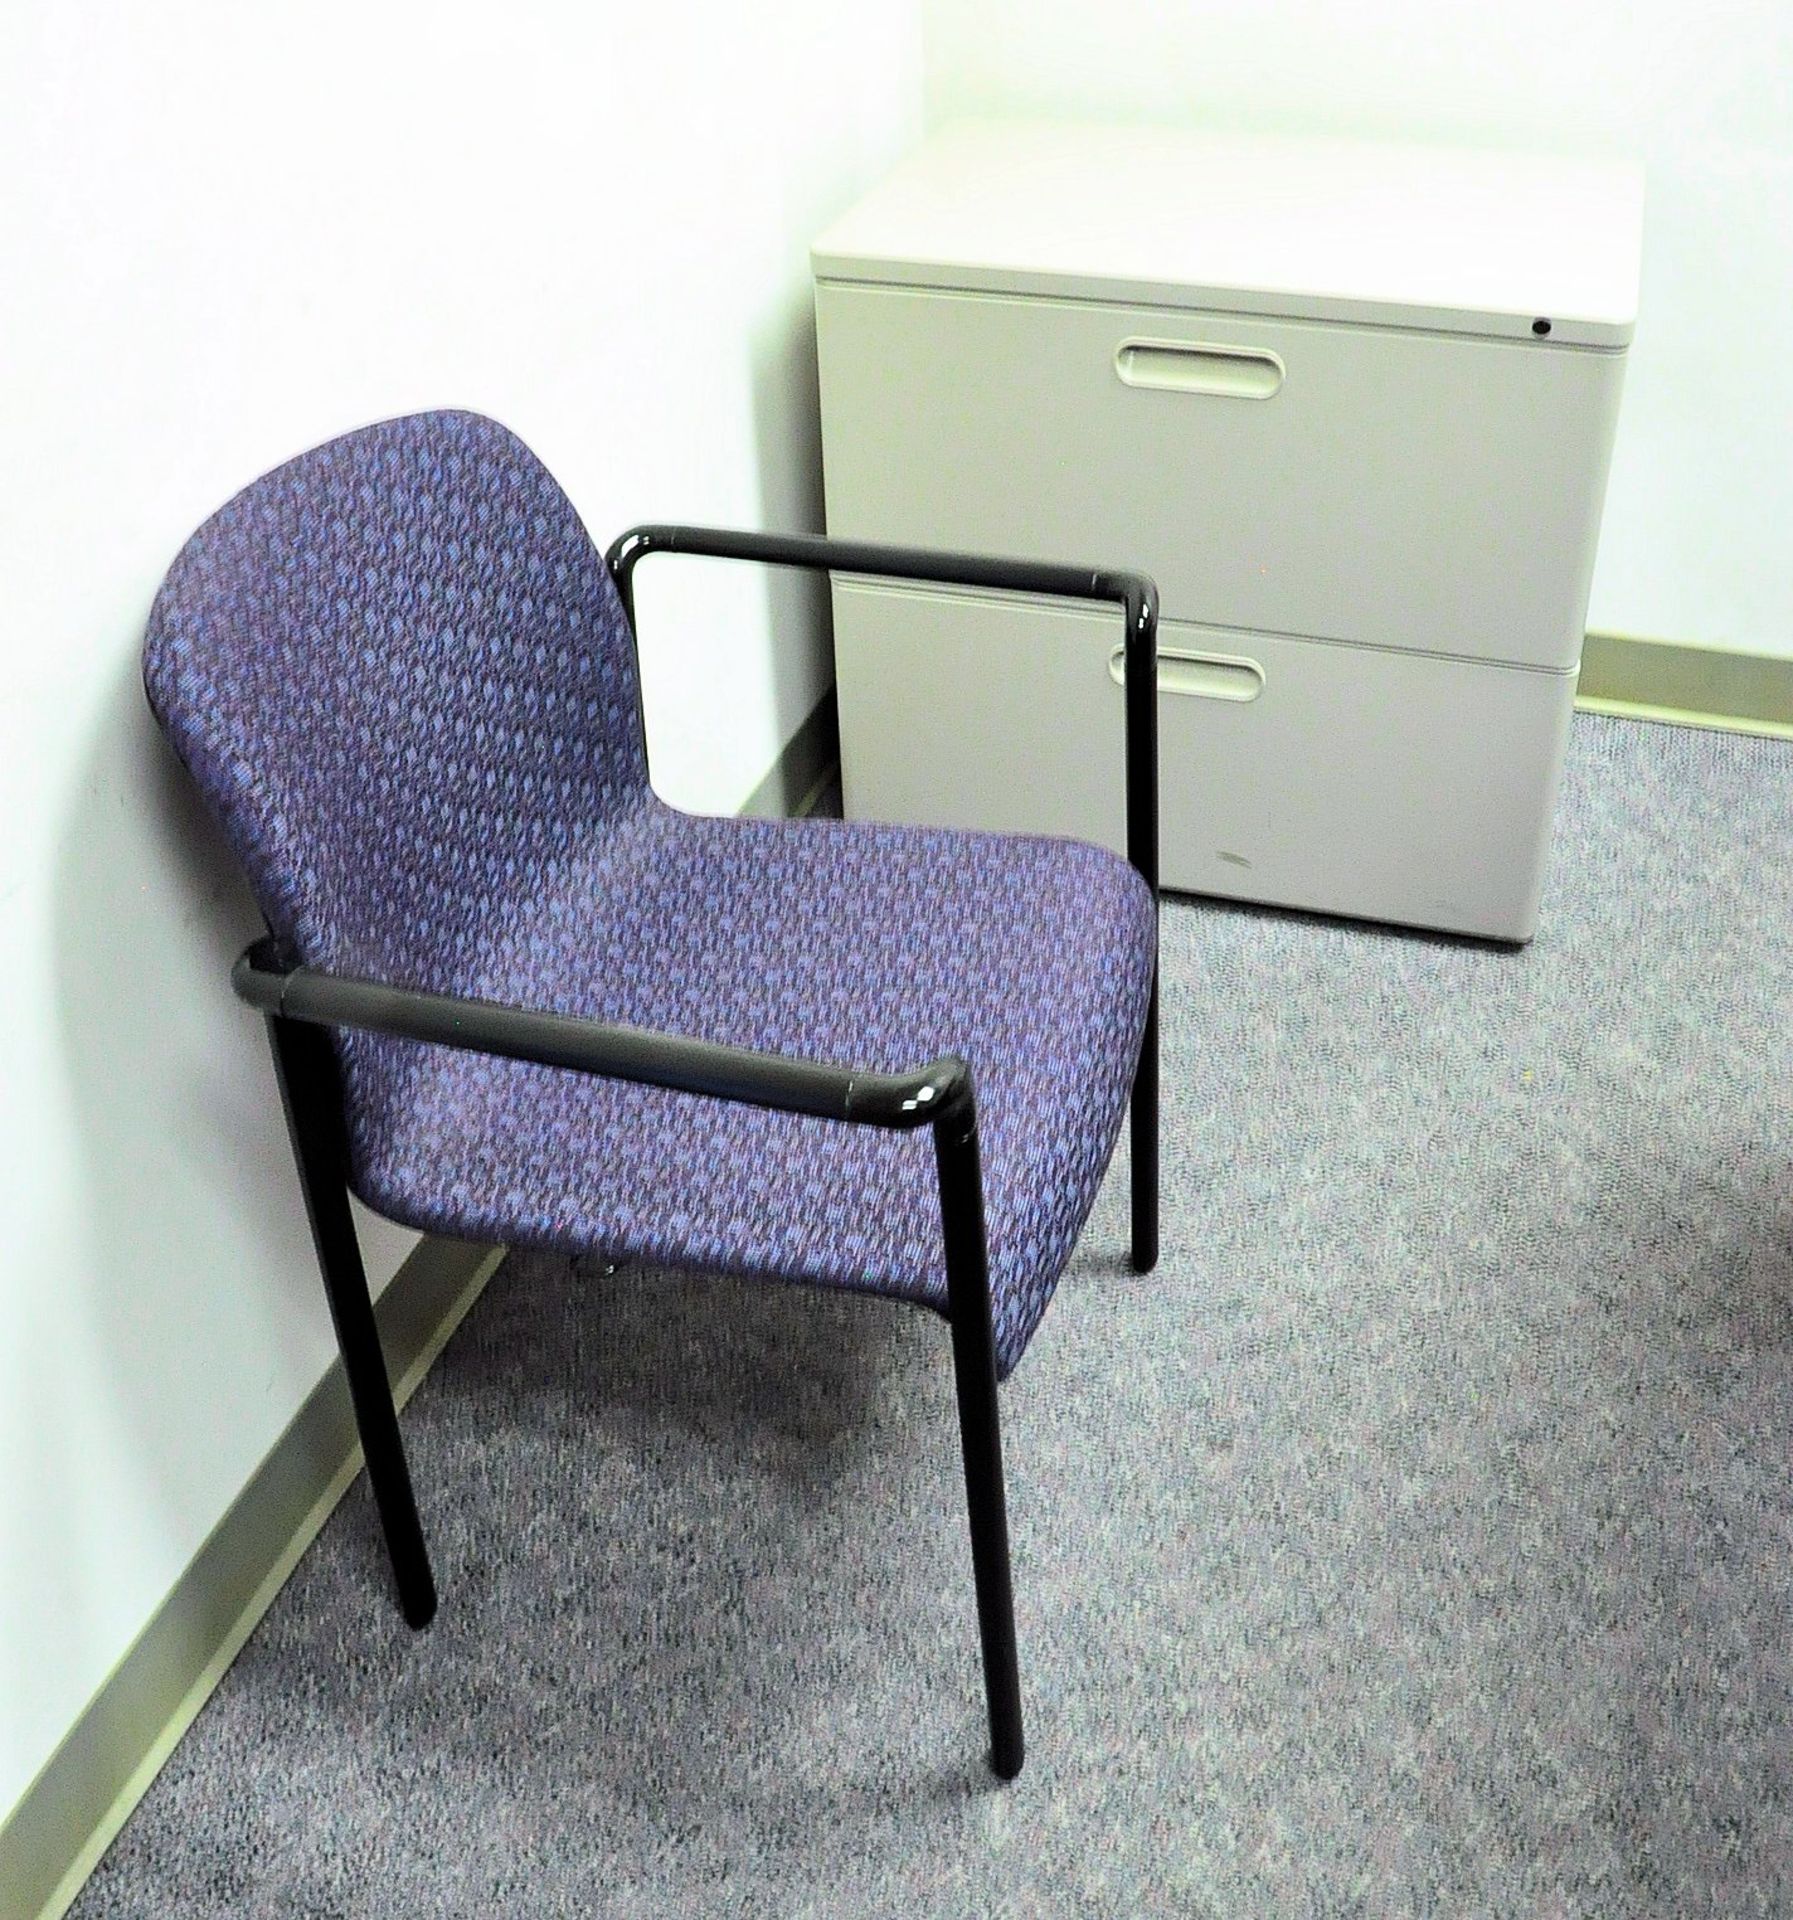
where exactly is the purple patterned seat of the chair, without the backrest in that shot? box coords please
[340,795,1158,1375]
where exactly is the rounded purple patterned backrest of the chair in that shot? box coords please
[144,413,647,985]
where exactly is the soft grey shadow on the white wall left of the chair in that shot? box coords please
[43,641,318,1609]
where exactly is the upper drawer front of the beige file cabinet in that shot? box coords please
[816,282,1624,668]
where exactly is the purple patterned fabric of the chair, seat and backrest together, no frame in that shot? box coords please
[144,413,1156,1375]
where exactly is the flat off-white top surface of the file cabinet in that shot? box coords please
[812,121,1643,349]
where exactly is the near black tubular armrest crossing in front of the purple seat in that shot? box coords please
[230,939,971,1129]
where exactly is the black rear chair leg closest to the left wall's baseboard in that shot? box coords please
[267,1014,436,1628]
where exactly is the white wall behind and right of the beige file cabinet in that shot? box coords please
[923,0,1793,657]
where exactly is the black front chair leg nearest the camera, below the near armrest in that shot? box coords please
[933,1106,1023,1780]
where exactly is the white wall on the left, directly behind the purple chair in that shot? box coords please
[0,0,921,1814]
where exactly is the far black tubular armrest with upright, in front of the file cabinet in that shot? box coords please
[605,526,1158,897]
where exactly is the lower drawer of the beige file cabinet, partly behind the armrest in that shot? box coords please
[833,576,1574,941]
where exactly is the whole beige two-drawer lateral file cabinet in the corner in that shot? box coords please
[812,125,1641,941]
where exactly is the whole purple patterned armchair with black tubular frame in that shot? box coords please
[144,413,1158,1778]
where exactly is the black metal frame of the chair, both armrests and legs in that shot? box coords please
[232,526,1158,1780]
